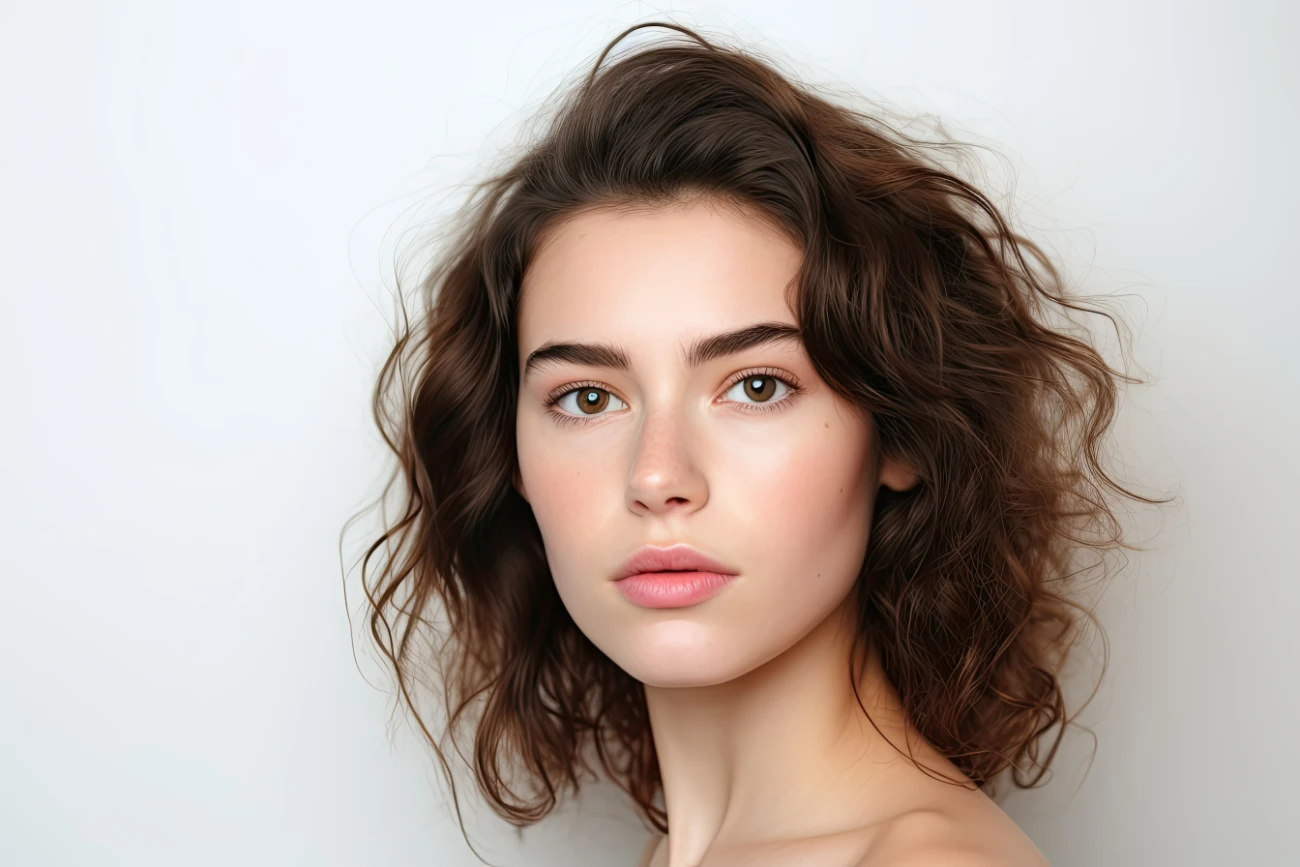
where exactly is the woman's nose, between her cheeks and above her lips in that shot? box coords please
[627,411,709,515]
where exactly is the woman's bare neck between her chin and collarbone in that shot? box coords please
[646,594,959,867]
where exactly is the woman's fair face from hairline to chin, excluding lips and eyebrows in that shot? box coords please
[516,203,914,686]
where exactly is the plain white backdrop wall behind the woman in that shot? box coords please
[0,0,1300,867]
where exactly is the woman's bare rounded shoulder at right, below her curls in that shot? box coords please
[854,792,1050,867]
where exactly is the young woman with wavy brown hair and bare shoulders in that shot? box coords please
[351,25,1153,867]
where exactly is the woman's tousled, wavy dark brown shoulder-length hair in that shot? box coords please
[345,22,1166,863]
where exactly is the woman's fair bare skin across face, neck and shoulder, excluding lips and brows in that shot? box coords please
[515,200,1047,867]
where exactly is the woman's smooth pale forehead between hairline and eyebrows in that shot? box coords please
[517,201,802,354]
